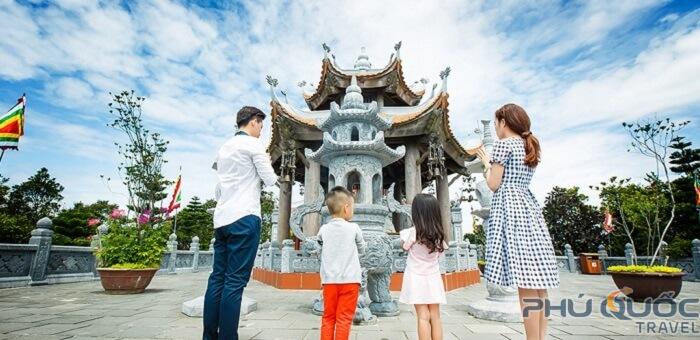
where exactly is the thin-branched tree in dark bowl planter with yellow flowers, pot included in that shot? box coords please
[596,119,689,301]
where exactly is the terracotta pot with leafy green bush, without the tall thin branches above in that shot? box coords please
[95,209,169,294]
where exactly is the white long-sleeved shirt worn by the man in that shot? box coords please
[214,134,277,228]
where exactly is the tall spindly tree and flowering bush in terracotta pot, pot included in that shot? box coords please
[96,90,173,294]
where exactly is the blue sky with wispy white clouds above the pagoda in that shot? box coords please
[0,0,700,212]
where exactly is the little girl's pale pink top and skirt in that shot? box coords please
[399,228,447,305]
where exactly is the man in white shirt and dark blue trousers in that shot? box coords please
[203,106,277,340]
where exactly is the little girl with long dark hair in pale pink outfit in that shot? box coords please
[399,194,447,340]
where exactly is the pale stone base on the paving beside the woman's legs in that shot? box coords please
[467,282,522,322]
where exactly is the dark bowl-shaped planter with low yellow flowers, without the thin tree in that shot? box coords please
[608,265,685,301]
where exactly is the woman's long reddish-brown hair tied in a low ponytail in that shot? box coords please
[496,103,540,168]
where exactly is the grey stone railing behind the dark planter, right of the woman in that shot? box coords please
[556,239,700,281]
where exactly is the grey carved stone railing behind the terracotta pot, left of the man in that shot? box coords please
[0,218,214,288]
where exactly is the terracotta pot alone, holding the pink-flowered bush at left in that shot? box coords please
[97,268,158,294]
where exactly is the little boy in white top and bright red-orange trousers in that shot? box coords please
[318,187,367,340]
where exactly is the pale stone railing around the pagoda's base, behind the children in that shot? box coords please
[255,235,477,273]
